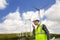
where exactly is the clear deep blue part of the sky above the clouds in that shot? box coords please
[0,0,56,22]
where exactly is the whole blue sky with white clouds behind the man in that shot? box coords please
[0,0,60,34]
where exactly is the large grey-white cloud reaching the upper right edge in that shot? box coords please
[46,0,60,21]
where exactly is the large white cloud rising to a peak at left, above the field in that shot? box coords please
[0,9,23,33]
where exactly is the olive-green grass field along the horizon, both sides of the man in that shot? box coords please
[0,32,60,40]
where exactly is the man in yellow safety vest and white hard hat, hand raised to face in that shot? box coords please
[32,19,50,40]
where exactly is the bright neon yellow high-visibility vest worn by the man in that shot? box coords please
[35,24,47,40]
